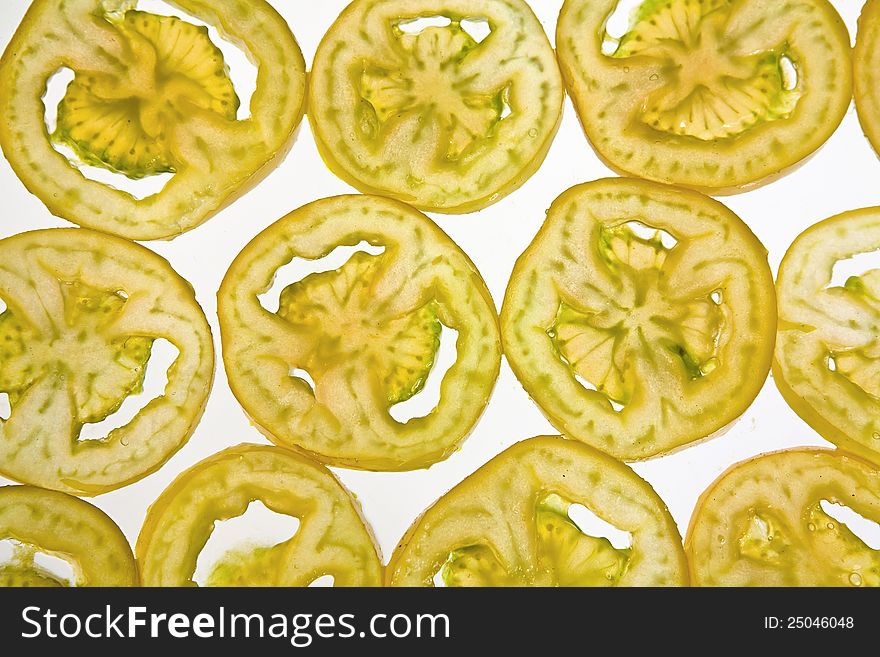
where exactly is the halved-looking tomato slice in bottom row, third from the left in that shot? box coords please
[385,436,687,586]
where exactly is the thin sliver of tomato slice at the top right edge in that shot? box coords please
[853,0,880,159]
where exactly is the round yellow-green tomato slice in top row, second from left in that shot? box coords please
[309,0,564,213]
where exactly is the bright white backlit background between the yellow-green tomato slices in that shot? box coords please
[0,0,880,576]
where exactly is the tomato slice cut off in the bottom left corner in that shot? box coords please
[0,486,138,587]
